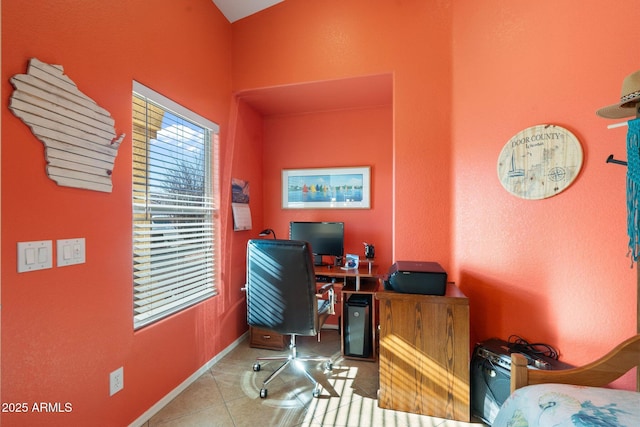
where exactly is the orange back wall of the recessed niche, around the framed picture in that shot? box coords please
[263,107,393,268]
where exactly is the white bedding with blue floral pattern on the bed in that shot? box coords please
[493,384,640,427]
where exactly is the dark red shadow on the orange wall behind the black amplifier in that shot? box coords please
[460,270,556,348]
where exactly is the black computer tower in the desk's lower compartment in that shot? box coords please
[343,294,371,357]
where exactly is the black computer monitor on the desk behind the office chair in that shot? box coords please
[289,221,344,265]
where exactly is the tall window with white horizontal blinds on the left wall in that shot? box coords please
[132,82,218,329]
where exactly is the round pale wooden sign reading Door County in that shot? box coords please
[498,125,582,200]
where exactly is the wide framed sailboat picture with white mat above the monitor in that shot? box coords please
[282,166,371,209]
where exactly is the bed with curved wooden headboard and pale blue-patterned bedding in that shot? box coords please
[492,334,640,427]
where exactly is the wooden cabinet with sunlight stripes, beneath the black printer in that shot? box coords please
[376,284,470,422]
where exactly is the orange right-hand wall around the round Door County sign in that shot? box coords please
[452,0,640,384]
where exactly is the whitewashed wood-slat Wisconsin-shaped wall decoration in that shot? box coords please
[9,58,125,193]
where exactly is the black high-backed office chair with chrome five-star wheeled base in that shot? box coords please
[246,240,335,399]
